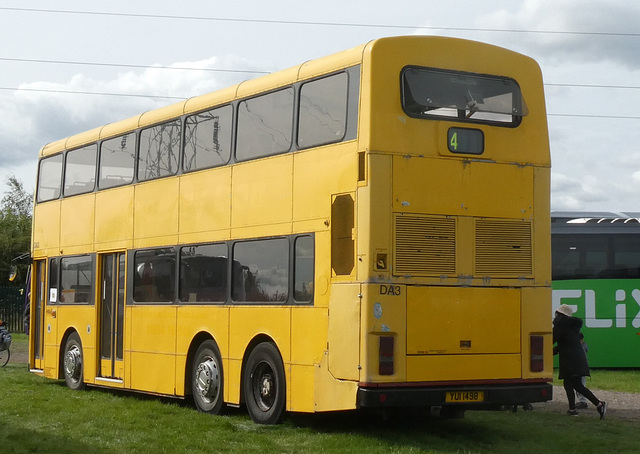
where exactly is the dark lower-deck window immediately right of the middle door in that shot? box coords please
[133,248,176,303]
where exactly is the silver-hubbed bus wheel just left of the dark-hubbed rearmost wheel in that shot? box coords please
[191,340,224,415]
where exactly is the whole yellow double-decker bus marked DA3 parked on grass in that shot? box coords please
[29,36,552,424]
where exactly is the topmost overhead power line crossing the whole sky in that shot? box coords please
[0,7,640,37]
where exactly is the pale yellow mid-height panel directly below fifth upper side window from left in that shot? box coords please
[179,167,231,242]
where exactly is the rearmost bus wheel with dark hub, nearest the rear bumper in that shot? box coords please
[244,342,286,424]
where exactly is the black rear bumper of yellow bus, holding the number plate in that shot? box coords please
[357,383,553,410]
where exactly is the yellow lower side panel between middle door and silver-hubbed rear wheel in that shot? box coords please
[125,305,177,394]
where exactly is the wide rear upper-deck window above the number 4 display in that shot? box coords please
[402,67,528,126]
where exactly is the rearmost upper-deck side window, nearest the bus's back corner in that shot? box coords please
[298,73,349,148]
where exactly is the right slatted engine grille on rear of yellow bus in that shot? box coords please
[474,219,533,277]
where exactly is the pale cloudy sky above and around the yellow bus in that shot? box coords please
[0,0,640,212]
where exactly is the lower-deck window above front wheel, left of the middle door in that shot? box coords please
[59,255,93,304]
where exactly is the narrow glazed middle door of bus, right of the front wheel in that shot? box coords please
[98,252,125,380]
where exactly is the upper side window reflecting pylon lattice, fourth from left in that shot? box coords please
[138,120,182,181]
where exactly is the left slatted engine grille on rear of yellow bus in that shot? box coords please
[394,216,456,276]
